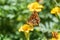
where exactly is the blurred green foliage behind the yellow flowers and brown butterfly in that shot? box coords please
[0,0,60,40]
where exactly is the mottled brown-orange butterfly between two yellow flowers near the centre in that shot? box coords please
[27,12,40,26]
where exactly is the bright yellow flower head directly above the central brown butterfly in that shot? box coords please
[28,2,43,12]
